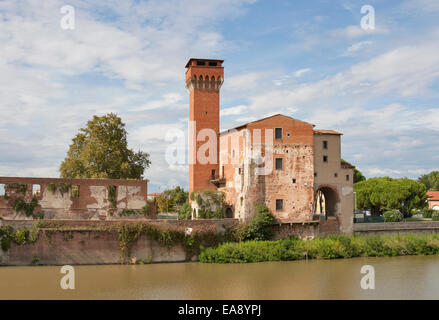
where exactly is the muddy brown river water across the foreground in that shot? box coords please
[0,256,439,300]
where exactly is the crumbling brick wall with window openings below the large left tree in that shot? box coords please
[0,177,155,219]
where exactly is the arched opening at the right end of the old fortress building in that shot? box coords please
[314,185,341,218]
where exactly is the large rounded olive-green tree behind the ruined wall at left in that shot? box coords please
[59,113,151,179]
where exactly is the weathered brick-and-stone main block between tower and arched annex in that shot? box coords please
[219,115,314,222]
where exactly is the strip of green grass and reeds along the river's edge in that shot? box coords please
[199,234,439,263]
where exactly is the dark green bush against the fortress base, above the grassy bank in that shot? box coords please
[238,203,276,240]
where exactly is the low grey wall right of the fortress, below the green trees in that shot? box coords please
[354,221,439,236]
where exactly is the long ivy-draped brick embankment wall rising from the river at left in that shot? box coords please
[0,219,241,266]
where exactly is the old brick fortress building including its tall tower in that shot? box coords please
[186,58,354,234]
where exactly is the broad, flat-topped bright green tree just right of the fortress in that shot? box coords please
[354,177,427,217]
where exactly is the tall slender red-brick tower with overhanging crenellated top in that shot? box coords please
[186,58,224,194]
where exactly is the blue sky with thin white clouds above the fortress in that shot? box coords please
[0,0,439,192]
